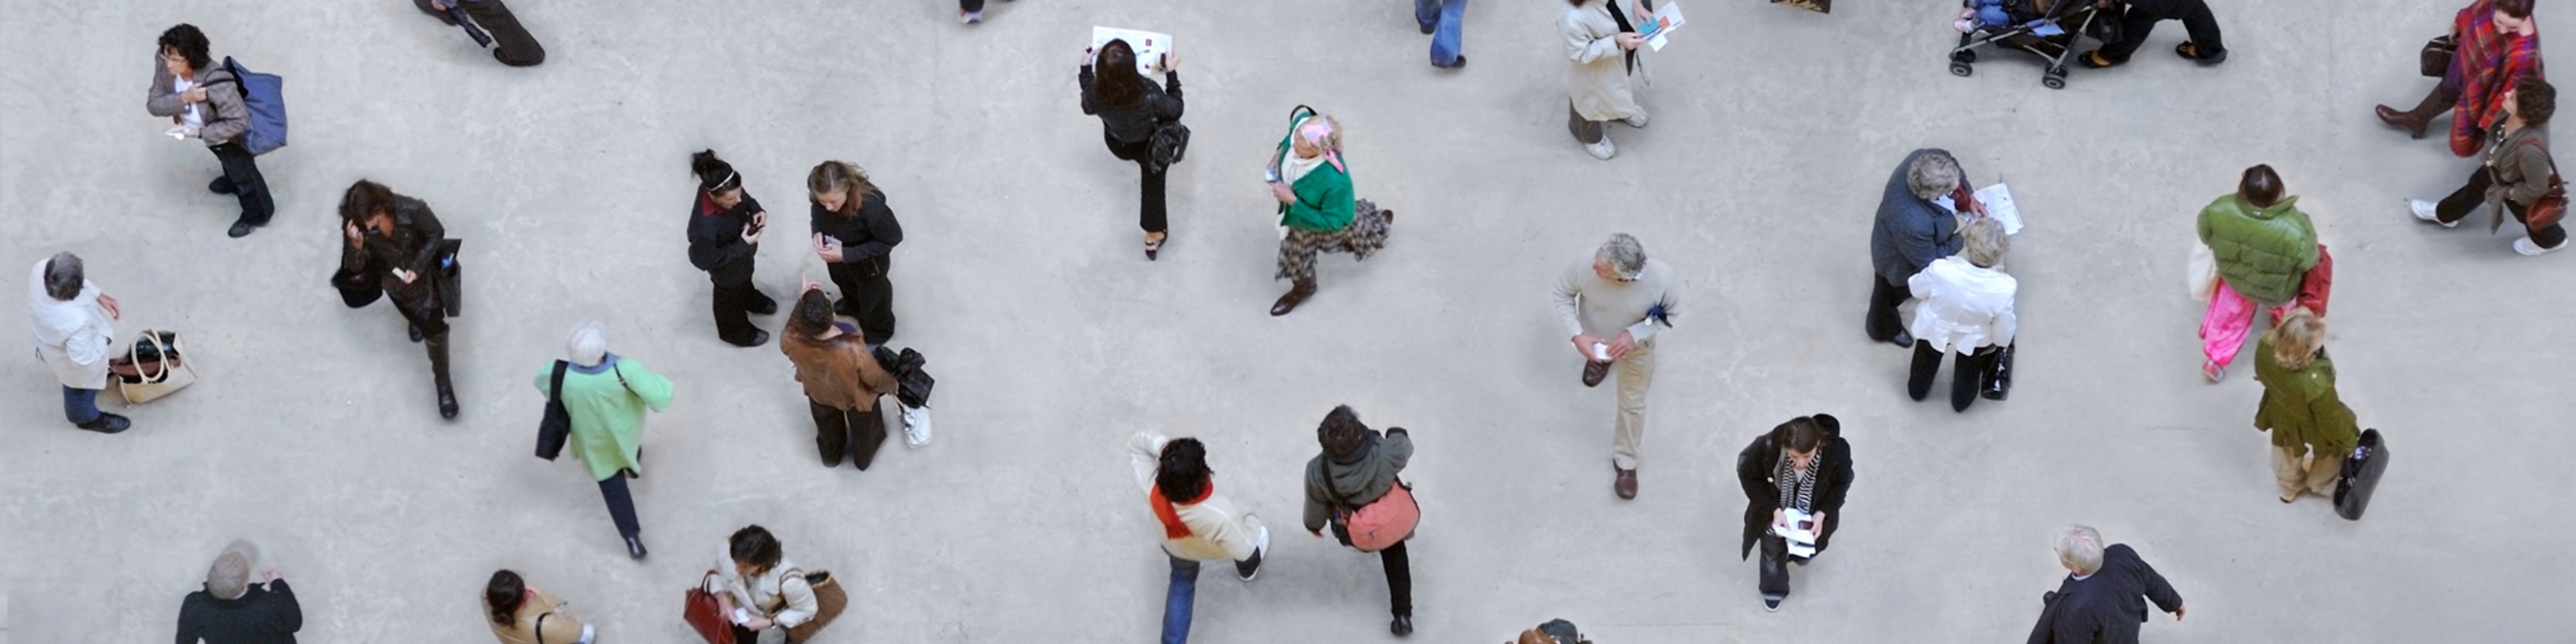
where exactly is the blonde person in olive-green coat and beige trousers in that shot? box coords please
[2254,307,2362,502]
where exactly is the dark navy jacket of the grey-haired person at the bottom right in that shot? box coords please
[2030,543,2182,644]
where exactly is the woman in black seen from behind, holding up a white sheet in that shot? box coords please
[1074,39,1183,260]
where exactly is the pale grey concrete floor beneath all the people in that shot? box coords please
[0,0,2576,644]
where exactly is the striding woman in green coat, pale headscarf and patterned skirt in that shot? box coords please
[1267,105,1396,314]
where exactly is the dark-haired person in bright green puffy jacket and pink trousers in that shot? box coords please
[2200,165,2318,381]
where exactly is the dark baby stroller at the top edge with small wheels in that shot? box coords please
[1950,0,2117,90]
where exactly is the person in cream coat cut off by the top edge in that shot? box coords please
[1556,0,1646,160]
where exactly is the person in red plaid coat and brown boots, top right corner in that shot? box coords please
[2373,0,2542,160]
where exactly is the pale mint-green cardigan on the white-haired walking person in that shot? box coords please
[536,353,672,482]
